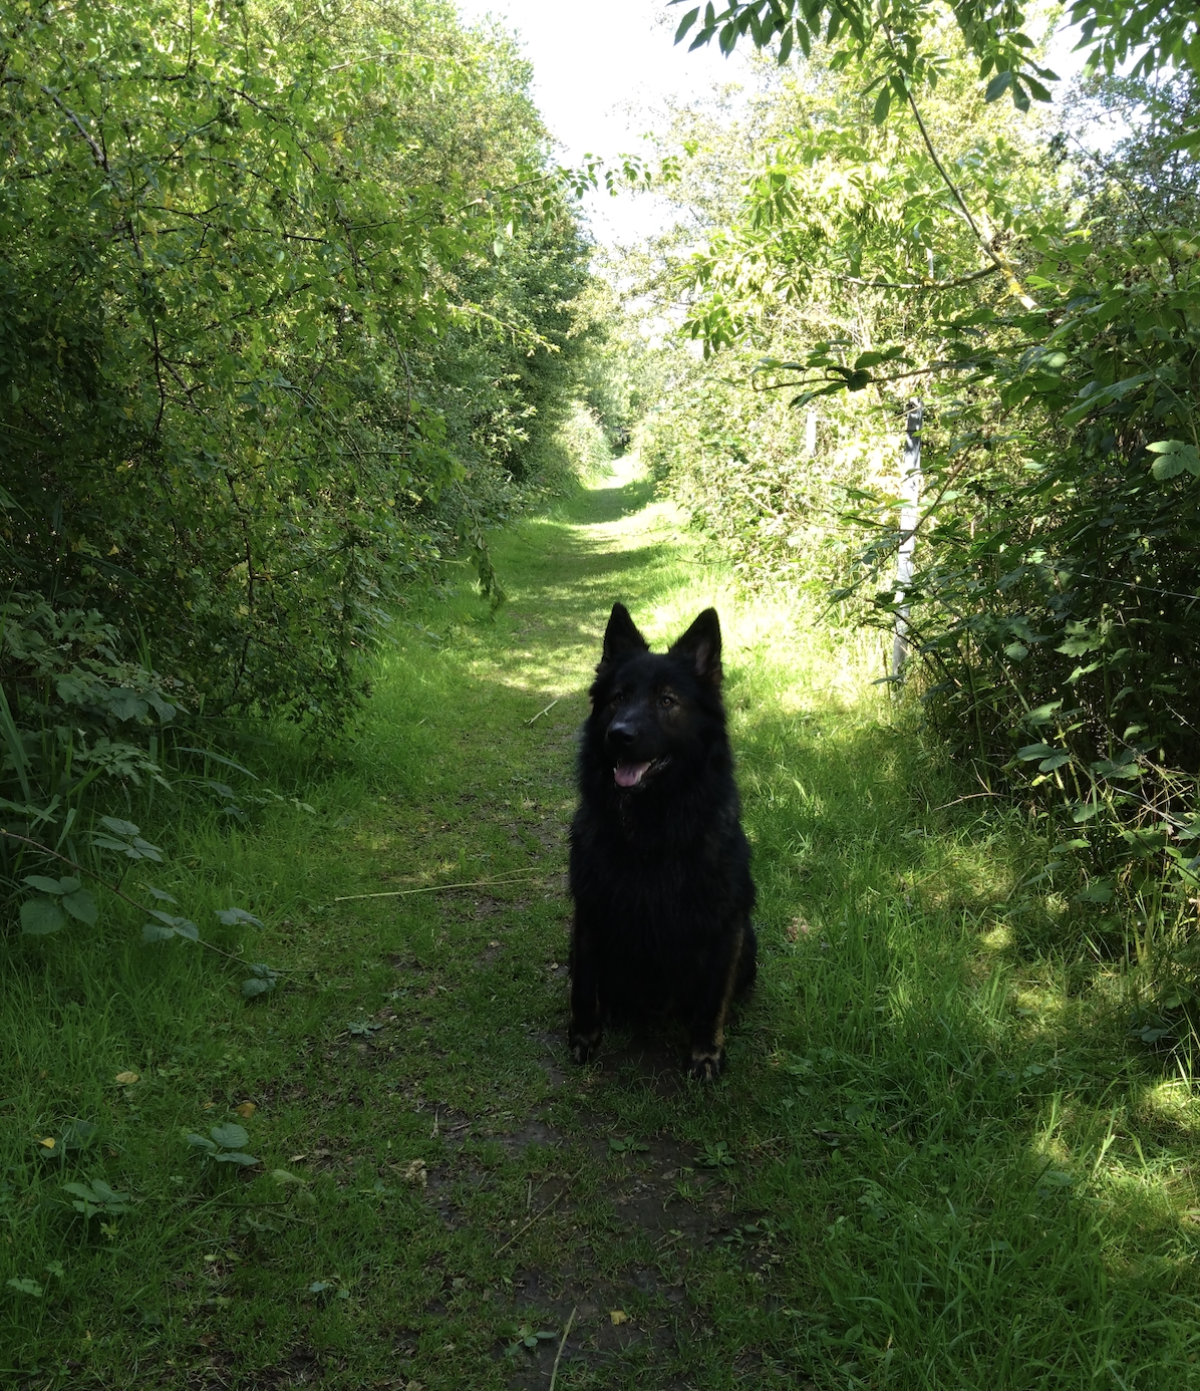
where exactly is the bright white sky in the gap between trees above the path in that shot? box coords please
[457,0,738,243]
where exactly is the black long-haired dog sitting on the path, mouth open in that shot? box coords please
[569,604,758,1079]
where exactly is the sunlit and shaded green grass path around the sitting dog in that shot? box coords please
[0,456,1200,1391]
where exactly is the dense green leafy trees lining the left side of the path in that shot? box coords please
[0,0,600,934]
